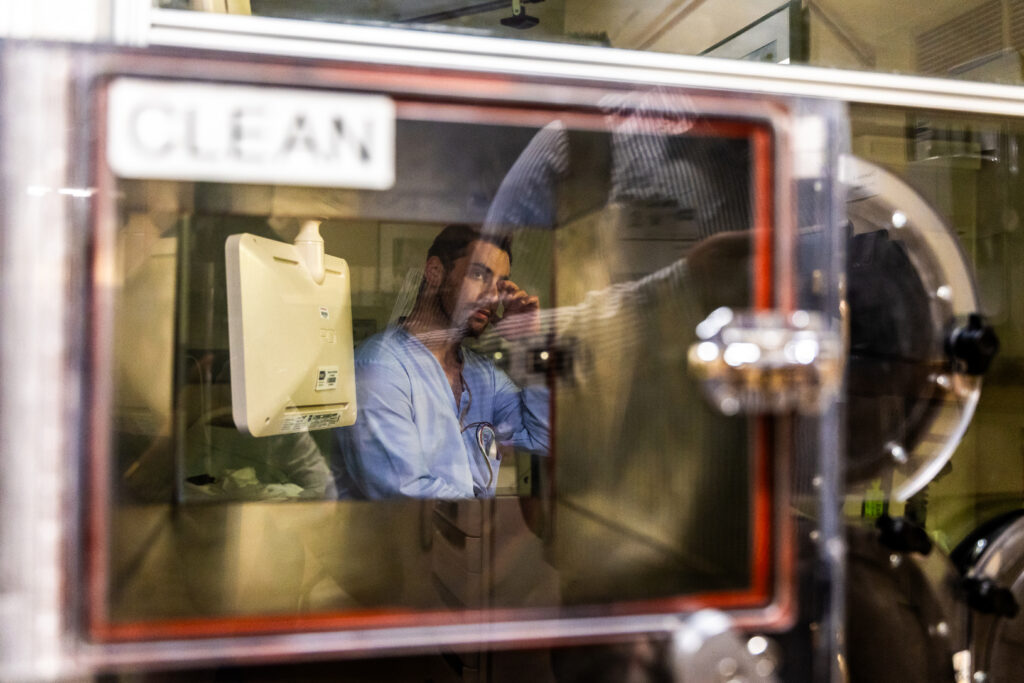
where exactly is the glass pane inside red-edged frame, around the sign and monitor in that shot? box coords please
[106,93,765,634]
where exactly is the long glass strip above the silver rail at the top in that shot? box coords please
[153,0,1024,84]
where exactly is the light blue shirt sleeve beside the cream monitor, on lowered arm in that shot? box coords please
[334,361,465,499]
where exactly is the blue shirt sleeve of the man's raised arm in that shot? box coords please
[494,368,551,456]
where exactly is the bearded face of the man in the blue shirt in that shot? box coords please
[437,240,510,337]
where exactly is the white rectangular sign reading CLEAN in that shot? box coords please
[106,78,395,189]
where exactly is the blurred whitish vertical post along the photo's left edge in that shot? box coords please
[0,45,77,680]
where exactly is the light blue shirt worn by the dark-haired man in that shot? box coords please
[332,328,549,499]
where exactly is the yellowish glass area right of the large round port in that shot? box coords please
[848,105,1024,550]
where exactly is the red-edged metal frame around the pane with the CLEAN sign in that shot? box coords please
[64,50,815,670]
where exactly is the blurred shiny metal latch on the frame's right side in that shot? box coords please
[688,307,845,415]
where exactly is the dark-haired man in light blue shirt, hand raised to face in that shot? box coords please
[334,225,548,499]
